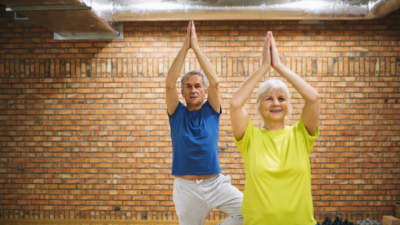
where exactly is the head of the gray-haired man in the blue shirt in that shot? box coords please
[181,74,208,106]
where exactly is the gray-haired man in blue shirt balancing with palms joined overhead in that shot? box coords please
[166,21,243,225]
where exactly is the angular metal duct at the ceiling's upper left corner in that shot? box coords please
[0,0,121,39]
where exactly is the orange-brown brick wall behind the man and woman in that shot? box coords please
[0,5,400,220]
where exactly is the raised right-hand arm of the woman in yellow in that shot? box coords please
[271,33,320,135]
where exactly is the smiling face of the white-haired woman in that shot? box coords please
[260,90,289,122]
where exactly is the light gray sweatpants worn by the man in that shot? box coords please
[173,174,243,225]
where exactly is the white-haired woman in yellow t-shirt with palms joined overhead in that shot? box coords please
[230,32,319,225]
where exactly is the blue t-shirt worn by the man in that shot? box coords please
[168,101,221,175]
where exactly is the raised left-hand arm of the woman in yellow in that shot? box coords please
[230,32,272,140]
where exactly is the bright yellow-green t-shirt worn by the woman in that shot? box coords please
[233,118,319,225]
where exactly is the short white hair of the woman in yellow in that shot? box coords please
[256,78,292,119]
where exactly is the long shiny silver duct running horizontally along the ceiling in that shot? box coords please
[80,0,400,22]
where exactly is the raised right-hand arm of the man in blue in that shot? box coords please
[190,21,221,112]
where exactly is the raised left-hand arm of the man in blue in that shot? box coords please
[165,22,190,115]
